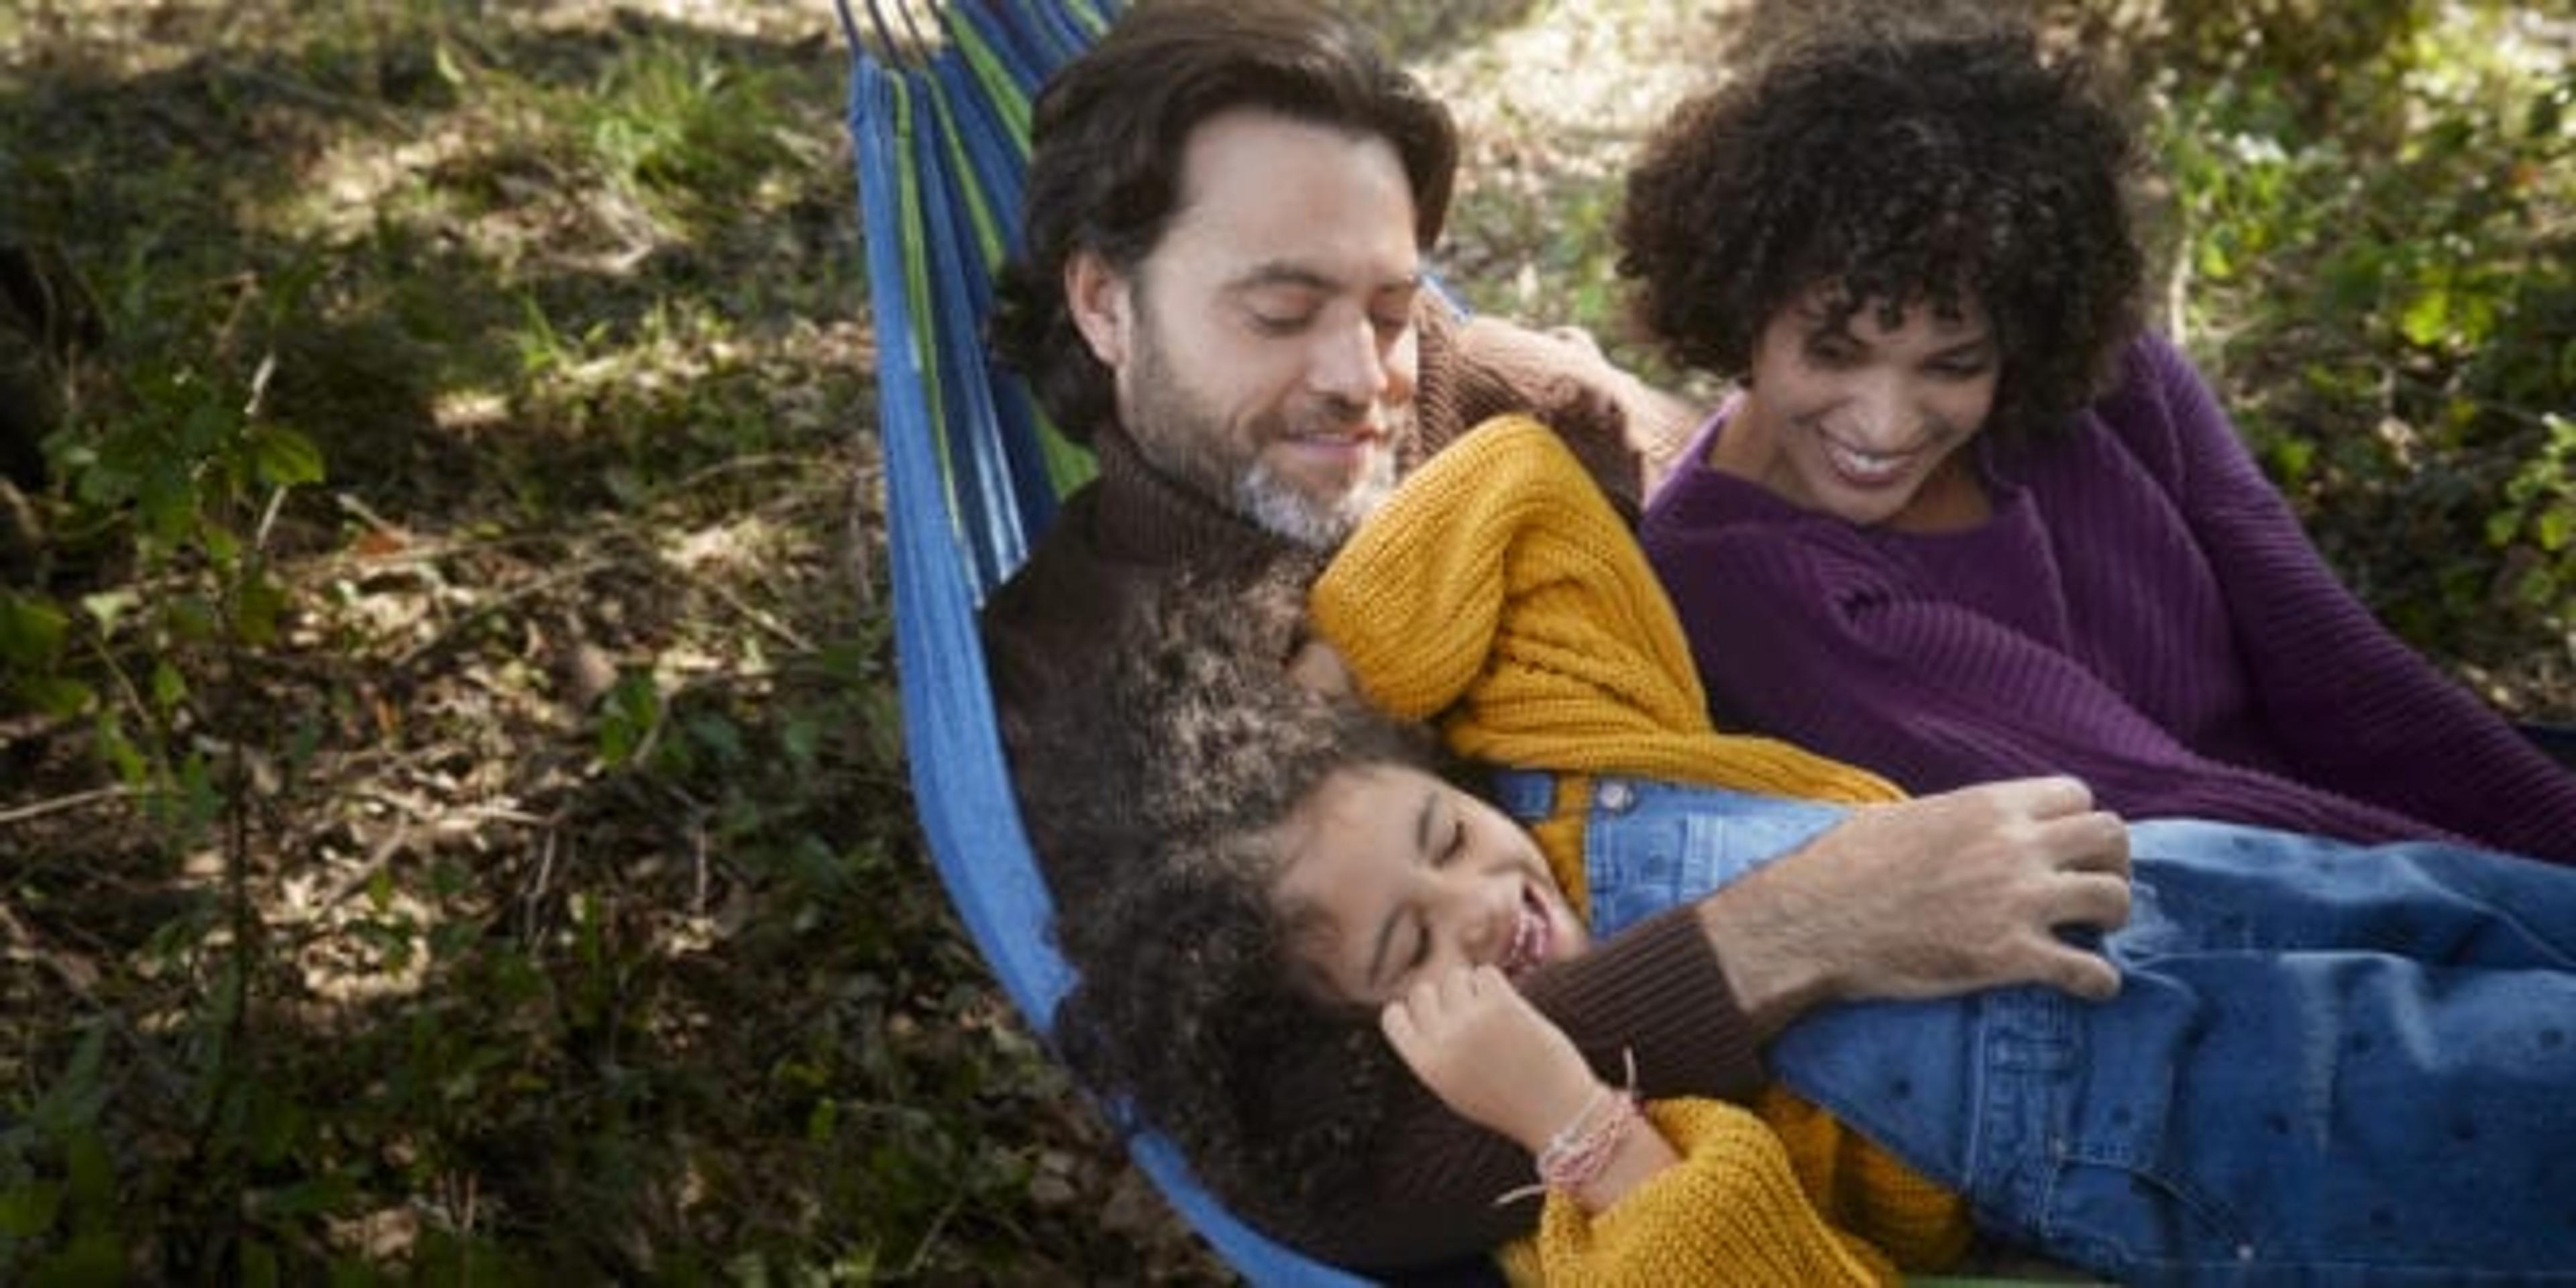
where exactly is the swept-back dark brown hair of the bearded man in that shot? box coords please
[991,0,1458,443]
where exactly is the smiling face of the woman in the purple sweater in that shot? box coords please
[1729,288,2002,528]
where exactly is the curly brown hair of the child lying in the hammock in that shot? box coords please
[1054,577,1438,1224]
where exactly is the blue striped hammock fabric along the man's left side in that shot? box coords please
[843,0,1362,1285]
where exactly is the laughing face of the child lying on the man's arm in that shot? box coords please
[1273,765,1587,1002]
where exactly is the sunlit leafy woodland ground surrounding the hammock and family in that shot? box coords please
[0,0,2576,1283]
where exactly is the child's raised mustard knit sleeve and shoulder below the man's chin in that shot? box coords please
[1309,417,1904,892]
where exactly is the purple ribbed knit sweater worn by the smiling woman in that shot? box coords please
[1644,337,2576,863]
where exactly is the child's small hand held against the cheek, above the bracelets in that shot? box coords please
[1378,966,1600,1154]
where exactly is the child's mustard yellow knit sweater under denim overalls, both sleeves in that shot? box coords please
[1309,417,1968,1285]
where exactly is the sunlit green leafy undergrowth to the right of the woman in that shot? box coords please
[2156,3,2576,675]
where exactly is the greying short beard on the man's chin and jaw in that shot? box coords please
[1126,322,1401,551]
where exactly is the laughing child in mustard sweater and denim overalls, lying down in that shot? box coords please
[1059,423,2576,1283]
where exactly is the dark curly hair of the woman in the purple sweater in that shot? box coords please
[1615,23,2143,443]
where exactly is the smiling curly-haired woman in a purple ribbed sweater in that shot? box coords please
[1618,20,2576,863]
